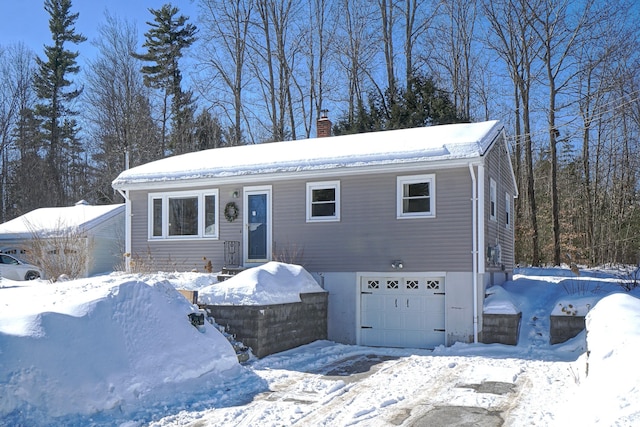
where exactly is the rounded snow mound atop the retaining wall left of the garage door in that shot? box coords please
[198,262,324,305]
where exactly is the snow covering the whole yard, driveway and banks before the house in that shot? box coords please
[0,264,640,427]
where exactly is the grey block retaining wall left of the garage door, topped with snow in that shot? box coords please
[200,292,328,357]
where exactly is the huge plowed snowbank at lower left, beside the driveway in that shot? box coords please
[0,275,239,425]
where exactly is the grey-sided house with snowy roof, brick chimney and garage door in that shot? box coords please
[113,119,517,348]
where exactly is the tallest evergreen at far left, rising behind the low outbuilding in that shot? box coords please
[34,0,86,206]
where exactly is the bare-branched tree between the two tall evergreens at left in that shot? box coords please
[84,13,163,203]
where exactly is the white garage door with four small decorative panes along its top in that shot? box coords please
[360,275,445,348]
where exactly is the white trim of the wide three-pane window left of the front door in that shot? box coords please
[147,189,220,241]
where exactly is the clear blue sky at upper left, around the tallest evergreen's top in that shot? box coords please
[0,0,197,63]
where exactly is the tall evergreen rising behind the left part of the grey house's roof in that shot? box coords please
[133,3,197,152]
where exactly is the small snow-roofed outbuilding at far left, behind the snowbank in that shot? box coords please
[0,200,125,277]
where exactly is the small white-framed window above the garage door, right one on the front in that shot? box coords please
[396,174,436,218]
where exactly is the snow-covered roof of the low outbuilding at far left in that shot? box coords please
[0,203,125,240]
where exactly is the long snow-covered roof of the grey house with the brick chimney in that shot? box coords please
[112,120,502,189]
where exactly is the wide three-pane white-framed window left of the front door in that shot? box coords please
[149,190,218,239]
